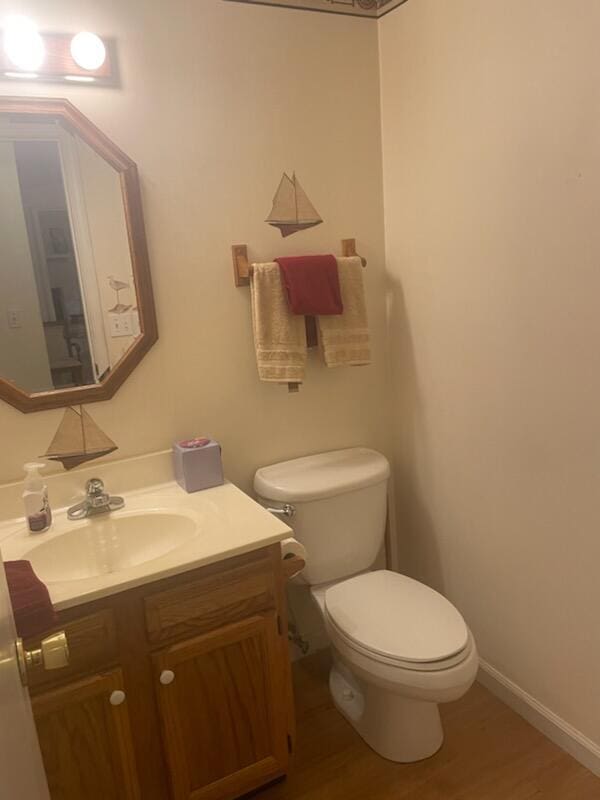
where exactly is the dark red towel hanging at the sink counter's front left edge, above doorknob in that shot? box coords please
[4,561,56,639]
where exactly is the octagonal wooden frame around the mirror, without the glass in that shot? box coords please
[0,97,158,413]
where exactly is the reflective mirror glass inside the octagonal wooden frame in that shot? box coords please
[0,114,140,393]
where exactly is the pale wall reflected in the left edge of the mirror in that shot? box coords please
[0,142,52,396]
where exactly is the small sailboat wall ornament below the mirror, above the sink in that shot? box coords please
[42,406,117,470]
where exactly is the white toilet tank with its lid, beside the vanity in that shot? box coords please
[254,447,390,585]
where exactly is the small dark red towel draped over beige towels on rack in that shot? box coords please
[276,256,344,316]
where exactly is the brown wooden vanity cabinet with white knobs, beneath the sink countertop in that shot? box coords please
[26,545,294,800]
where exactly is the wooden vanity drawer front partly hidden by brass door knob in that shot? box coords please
[24,609,118,694]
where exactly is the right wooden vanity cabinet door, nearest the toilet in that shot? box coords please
[154,611,288,800]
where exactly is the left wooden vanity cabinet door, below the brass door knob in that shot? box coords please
[32,669,140,800]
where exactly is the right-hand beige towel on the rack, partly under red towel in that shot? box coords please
[319,256,371,367]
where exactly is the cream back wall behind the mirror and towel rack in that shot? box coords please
[0,0,398,490]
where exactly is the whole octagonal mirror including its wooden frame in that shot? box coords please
[0,97,157,412]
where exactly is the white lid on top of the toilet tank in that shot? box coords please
[254,447,390,503]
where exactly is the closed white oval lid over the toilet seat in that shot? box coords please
[325,570,469,663]
